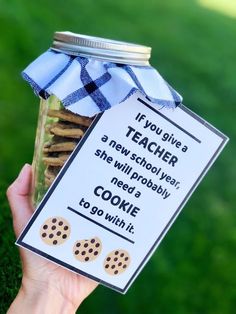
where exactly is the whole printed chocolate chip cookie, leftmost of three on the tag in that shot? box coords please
[40,217,70,245]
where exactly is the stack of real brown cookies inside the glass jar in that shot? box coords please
[43,109,92,187]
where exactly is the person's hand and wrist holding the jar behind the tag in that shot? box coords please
[7,164,97,314]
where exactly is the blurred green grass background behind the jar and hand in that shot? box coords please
[0,0,236,314]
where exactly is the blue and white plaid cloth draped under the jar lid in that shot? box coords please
[22,49,182,117]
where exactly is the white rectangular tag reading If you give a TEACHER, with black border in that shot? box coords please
[17,93,228,293]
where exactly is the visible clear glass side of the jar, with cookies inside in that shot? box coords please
[33,96,93,206]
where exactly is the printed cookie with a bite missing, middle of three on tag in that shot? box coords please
[73,237,102,262]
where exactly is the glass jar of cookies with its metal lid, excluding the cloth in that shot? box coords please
[30,32,151,206]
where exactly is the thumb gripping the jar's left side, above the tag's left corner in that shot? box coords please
[7,164,33,236]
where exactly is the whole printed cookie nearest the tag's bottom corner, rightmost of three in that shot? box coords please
[103,250,130,275]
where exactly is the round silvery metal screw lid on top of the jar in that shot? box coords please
[51,32,151,65]
